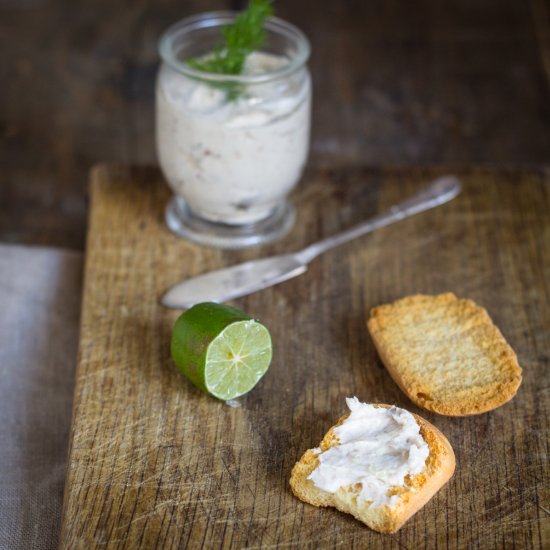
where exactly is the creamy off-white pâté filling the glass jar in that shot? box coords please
[157,52,311,225]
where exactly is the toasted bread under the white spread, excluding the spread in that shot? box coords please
[290,405,455,533]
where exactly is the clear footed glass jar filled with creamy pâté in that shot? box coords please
[156,12,311,248]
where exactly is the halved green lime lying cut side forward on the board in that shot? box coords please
[171,302,272,401]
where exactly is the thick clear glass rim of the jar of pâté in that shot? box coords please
[158,11,311,84]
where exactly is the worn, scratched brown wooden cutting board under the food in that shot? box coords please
[61,165,550,549]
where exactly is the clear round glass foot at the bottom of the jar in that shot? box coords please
[165,196,296,250]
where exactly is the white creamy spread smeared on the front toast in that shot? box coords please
[308,397,430,507]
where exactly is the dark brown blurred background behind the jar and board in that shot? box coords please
[0,0,550,249]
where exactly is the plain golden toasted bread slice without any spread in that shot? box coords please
[368,293,521,416]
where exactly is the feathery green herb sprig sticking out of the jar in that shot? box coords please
[187,0,273,99]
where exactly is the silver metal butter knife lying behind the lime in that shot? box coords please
[161,176,461,309]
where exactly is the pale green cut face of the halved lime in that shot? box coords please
[205,320,272,400]
